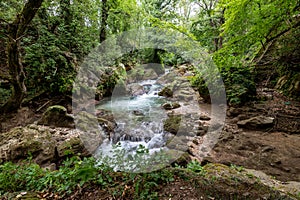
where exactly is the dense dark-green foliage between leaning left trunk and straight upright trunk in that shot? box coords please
[23,1,97,92]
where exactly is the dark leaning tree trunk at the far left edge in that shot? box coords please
[1,0,43,113]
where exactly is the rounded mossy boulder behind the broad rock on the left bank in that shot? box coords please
[38,105,75,128]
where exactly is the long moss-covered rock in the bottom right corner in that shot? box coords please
[198,163,299,200]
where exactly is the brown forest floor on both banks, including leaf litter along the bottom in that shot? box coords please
[0,85,300,200]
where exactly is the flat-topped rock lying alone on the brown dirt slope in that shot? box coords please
[237,115,274,129]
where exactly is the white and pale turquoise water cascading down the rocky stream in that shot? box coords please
[97,75,172,170]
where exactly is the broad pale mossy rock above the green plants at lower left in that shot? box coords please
[0,125,91,166]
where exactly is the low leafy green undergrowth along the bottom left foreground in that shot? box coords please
[0,156,203,199]
